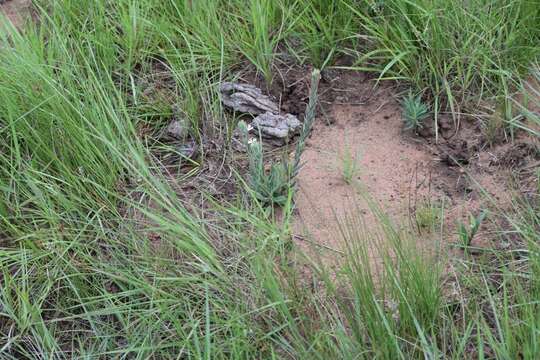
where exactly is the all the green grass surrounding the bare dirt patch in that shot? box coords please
[0,0,540,359]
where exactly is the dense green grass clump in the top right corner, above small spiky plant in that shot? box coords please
[349,0,540,129]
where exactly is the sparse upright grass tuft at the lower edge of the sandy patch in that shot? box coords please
[330,207,444,359]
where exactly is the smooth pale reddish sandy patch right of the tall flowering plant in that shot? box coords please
[295,75,435,253]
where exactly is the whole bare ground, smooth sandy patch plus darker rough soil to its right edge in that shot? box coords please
[284,72,538,258]
